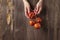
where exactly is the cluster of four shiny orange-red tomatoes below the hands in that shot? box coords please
[29,12,42,29]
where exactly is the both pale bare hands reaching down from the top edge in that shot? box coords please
[23,0,43,18]
